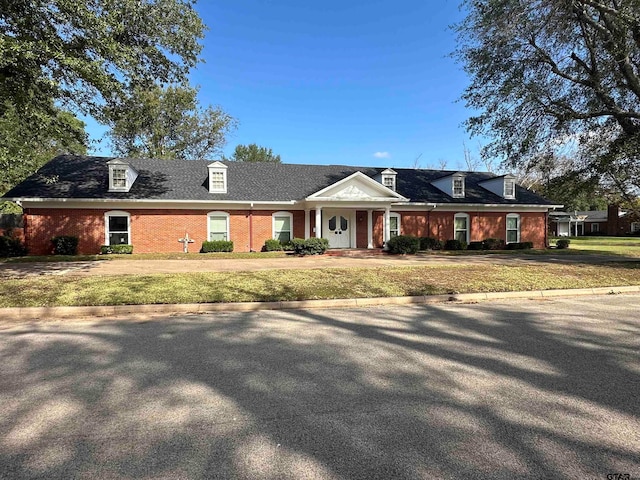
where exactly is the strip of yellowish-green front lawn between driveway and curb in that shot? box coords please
[0,262,640,307]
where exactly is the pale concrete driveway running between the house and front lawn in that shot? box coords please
[0,254,640,278]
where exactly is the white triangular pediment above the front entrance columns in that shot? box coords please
[307,172,408,202]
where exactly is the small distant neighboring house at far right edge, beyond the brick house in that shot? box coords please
[549,205,640,237]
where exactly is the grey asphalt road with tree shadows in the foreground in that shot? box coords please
[0,295,640,480]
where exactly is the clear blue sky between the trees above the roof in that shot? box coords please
[88,0,478,168]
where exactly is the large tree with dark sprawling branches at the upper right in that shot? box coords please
[455,0,640,202]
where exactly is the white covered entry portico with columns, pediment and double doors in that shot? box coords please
[305,172,409,248]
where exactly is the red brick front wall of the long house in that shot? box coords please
[24,208,546,255]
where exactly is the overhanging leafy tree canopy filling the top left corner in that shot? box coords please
[0,0,205,119]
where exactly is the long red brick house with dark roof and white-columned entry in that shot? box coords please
[5,156,560,254]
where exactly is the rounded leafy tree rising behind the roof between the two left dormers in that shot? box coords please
[108,85,236,159]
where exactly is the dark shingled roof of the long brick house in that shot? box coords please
[4,155,552,205]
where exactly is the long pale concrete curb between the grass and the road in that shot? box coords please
[0,285,640,320]
